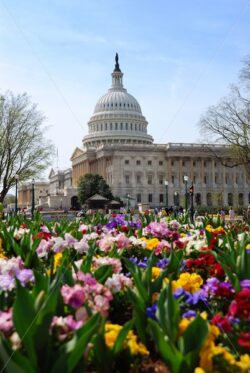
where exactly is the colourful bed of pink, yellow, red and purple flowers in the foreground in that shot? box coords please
[0,214,250,373]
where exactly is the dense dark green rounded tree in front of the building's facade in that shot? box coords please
[78,174,113,203]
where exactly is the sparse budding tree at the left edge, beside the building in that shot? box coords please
[0,92,54,202]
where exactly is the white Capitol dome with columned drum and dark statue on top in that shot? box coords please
[83,55,153,147]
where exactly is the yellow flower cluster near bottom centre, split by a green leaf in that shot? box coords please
[105,323,149,356]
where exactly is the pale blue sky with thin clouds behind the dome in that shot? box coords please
[0,0,250,175]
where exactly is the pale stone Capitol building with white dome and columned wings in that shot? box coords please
[18,54,250,209]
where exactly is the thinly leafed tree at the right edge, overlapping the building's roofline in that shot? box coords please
[199,55,250,177]
